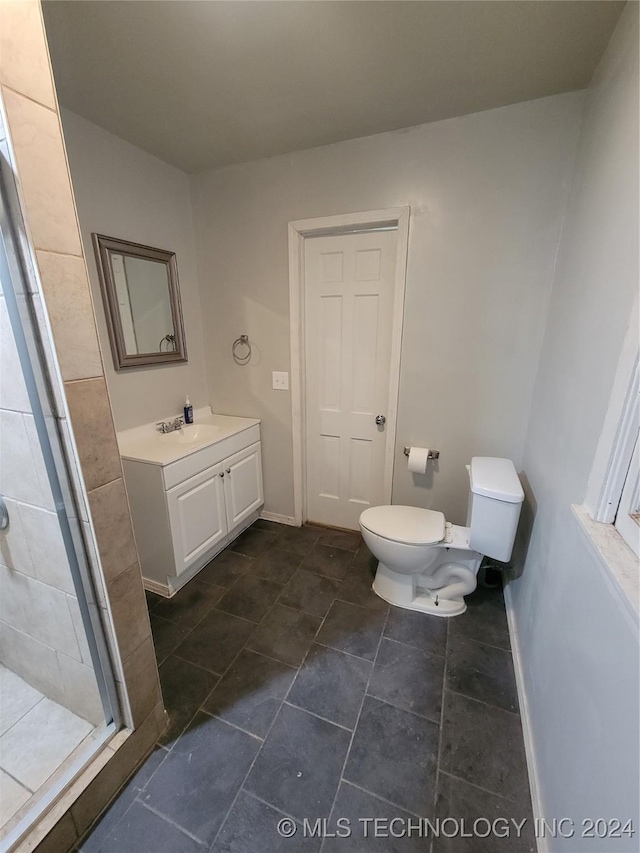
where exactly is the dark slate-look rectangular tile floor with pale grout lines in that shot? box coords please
[79,521,535,853]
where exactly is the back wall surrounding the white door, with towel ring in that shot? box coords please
[191,93,583,523]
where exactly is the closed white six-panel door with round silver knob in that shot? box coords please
[304,230,397,530]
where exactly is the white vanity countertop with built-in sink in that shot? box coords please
[118,408,260,465]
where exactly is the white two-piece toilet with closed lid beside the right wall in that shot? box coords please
[360,456,524,616]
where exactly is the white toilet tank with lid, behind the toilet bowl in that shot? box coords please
[467,456,524,563]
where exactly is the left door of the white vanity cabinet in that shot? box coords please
[167,464,228,575]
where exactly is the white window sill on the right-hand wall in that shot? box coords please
[571,504,640,622]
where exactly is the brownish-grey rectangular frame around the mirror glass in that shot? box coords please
[91,234,188,370]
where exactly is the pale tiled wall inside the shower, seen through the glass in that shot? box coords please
[0,282,104,724]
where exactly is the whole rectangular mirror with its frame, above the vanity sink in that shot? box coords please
[92,234,187,370]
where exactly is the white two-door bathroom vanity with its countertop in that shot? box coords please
[118,412,264,596]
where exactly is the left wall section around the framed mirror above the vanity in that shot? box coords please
[61,109,208,429]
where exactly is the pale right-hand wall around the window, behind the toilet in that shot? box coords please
[508,3,639,853]
